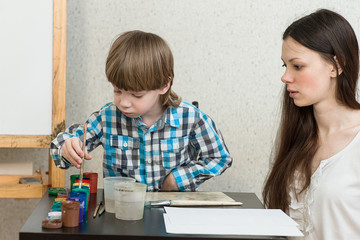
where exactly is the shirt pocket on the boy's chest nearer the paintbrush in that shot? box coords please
[110,135,140,170]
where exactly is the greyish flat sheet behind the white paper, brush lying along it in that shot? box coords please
[145,192,235,202]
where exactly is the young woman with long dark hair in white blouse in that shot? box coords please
[263,9,360,240]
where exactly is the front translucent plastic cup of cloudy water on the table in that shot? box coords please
[114,182,147,220]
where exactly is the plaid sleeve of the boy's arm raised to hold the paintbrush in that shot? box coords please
[50,112,102,169]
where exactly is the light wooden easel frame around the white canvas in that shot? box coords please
[0,0,67,198]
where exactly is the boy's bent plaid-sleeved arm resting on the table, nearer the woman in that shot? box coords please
[172,115,232,191]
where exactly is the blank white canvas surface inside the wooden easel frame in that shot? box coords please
[0,0,53,135]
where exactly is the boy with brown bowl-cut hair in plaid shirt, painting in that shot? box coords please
[51,31,232,191]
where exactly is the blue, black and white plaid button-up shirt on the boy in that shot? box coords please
[50,102,232,191]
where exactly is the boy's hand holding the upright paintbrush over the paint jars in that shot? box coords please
[62,137,92,168]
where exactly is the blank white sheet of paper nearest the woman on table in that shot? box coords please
[164,207,303,236]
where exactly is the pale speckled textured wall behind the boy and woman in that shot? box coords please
[0,0,360,239]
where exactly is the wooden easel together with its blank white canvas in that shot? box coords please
[0,0,67,195]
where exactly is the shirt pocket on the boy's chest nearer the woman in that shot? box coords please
[160,136,189,170]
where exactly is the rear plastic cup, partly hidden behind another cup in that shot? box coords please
[104,177,135,213]
